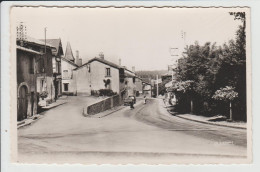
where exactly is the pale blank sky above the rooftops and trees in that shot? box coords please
[11,7,244,71]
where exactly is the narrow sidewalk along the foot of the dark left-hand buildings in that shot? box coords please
[17,96,68,129]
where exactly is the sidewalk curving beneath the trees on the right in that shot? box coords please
[161,99,247,129]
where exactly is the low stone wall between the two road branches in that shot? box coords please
[83,95,122,116]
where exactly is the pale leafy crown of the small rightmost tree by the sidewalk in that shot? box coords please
[212,86,238,101]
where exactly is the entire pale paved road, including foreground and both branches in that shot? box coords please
[18,97,247,163]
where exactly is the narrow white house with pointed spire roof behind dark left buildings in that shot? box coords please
[61,42,78,95]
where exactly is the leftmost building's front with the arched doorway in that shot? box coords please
[16,46,41,121]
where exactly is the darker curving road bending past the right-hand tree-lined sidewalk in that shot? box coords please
[125,99,247,147]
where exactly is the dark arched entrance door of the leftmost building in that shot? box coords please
[17,86,28,121]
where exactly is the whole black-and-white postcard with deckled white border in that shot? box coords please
[10,6,252,164]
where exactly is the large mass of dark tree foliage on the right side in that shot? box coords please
[170,12,246,120]
